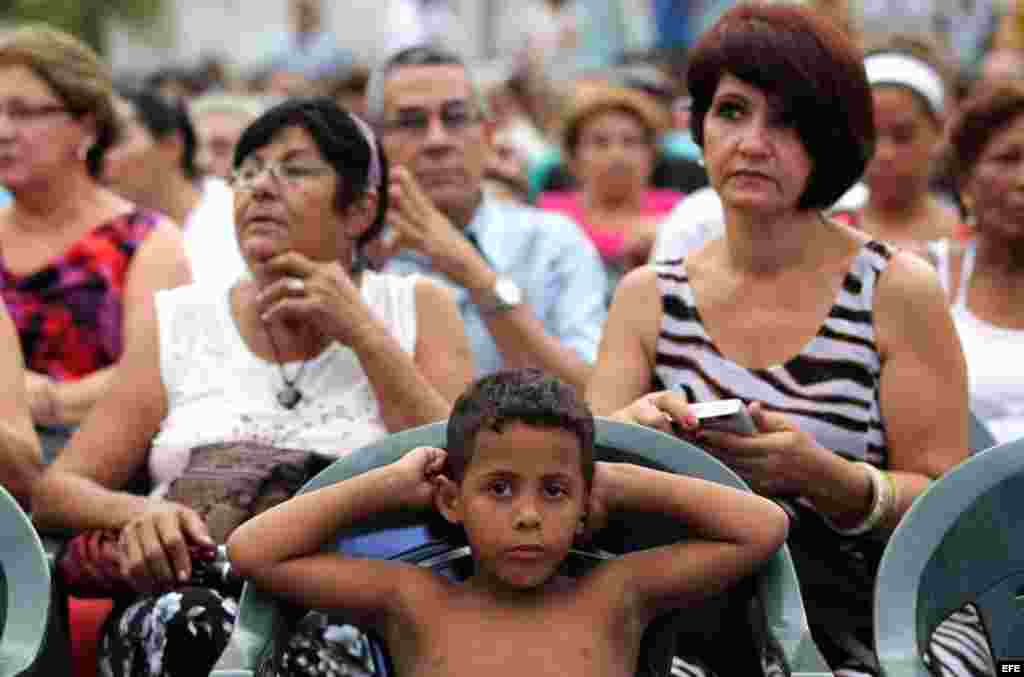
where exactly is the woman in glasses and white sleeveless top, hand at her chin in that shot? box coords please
[34,98,473,677]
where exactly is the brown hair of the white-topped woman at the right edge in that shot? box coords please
[947,80,1024,188]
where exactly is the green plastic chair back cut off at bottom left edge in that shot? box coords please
[0,486,50,677]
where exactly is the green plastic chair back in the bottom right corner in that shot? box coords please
[874,439,1024,677]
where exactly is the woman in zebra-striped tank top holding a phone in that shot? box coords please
[588,3,967,677]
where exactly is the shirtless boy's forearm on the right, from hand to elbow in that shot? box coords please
[609,463,787,544]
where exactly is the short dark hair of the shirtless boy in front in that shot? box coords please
[444,369,594,489]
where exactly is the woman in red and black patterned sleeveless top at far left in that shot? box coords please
[0,27,189,432]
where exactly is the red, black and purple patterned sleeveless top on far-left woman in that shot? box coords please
[0,210,160,381]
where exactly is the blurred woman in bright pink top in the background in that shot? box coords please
[538,84,682,279]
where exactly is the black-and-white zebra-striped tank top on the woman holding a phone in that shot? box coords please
[654,240,892,468]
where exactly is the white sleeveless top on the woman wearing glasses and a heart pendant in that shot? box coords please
[150,270,419,495]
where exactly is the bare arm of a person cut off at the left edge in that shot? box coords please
[0,306,43,506]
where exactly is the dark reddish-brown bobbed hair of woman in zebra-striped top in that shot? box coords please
[686,3,874,209]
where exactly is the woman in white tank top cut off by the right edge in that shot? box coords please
[934,82,1024,442]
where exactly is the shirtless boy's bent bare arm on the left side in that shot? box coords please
[227,448,445,628]
